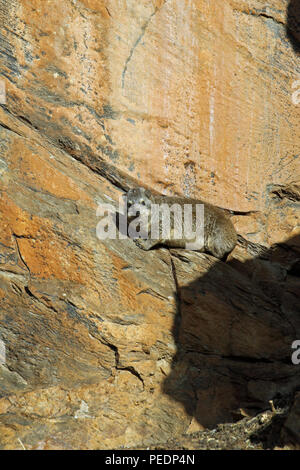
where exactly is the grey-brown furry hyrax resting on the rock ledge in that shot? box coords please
[127,188,237,259]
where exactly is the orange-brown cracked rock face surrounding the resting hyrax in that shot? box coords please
[0,0,300,449]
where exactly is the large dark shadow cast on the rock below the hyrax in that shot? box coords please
[163,236,300,445]
